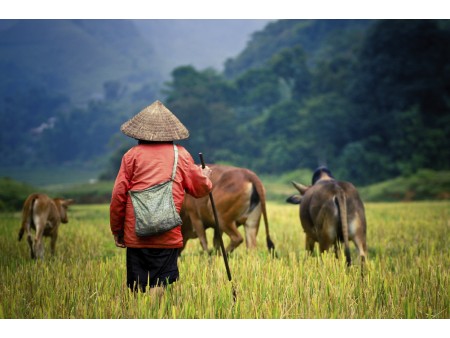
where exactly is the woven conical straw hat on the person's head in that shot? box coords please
[120,101,189,141]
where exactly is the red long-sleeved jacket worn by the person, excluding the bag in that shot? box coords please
[110,142,212,248]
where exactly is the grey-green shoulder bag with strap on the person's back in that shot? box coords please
[129,144,182,237]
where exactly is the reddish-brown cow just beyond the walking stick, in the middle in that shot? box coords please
[180,164,275,253]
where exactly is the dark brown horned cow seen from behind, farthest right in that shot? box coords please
[287,167,367,265]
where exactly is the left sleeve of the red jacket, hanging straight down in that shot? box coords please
[109,156,130,235]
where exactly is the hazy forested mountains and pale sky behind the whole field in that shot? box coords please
[0,19,450,203]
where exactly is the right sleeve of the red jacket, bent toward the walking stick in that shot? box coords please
[179,149,212,198]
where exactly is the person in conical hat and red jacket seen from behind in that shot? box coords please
[110,101,212,299]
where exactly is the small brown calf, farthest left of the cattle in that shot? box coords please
[19,194,73,259]
